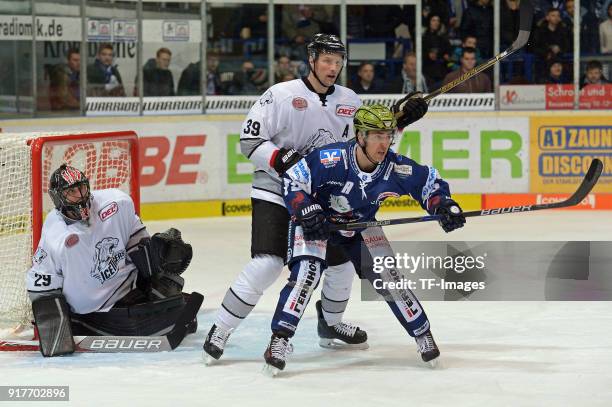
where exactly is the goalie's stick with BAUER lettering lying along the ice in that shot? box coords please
[0,292,204,353]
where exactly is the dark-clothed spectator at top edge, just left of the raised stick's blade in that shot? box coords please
[461,0,493,59]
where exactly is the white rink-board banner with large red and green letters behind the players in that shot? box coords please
[3,116,529,207]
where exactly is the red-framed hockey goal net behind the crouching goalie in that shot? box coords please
[0,132,140,330]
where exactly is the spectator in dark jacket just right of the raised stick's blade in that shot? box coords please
[533,8,572,61]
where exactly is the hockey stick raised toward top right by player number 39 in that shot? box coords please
[395,0,533,114]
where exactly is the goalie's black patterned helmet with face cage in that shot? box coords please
[49,164,91,221]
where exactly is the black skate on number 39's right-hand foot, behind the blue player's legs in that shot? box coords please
[316,301,369,349]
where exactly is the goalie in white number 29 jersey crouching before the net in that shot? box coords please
[26,164,197,356]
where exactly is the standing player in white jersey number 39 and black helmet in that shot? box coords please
[204,34,427,363]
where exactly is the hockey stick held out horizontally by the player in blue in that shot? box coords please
[330,158,603,230]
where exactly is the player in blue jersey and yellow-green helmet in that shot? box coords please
[264,105,465,375]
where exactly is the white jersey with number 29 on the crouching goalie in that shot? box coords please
[26,189,146,314]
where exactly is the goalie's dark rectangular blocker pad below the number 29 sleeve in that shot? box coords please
[32,294,75,356]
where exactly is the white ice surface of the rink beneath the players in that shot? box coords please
[0,211,612,407]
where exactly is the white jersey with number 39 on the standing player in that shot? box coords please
[240,79,361,206]
